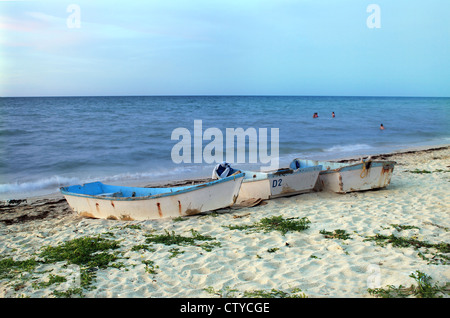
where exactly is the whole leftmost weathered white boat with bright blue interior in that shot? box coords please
[60,173,244,220]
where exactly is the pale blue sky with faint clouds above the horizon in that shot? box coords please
[0,0,450,97]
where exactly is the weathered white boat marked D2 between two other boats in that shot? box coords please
[213,164,322,203]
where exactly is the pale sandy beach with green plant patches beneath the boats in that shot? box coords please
[0,145,450,298]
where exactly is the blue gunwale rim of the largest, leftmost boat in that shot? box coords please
[60,172,245,201]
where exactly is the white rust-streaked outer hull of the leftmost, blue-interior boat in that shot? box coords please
[61,174,244,220]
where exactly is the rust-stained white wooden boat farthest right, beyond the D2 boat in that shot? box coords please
[291,158,396,193]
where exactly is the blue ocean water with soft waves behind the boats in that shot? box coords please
[0,96,450,199]
